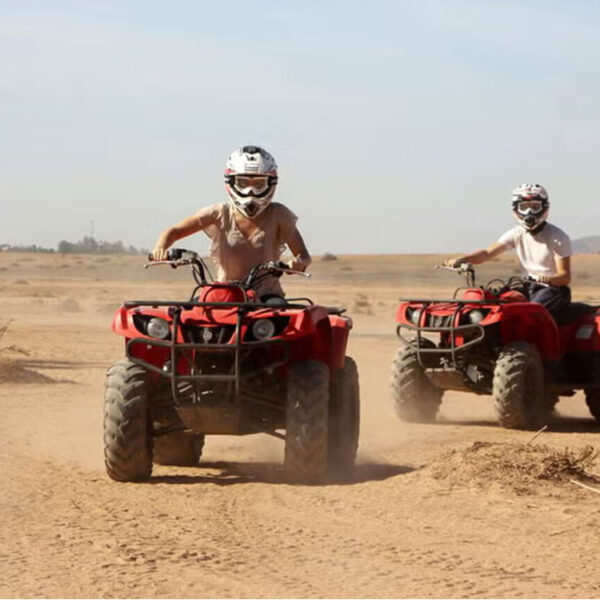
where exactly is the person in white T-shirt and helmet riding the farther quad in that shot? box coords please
[444,183,572,318]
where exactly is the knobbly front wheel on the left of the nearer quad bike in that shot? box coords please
[104,359,152,481]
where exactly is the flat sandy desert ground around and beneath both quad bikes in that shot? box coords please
[0,253,600,598]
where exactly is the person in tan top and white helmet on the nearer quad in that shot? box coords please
[152,146,311,299]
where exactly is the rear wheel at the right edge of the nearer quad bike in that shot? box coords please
[327,356,360,476]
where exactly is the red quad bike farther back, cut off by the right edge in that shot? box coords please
[391,263,600,429]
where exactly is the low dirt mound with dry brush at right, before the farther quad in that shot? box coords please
[430,442,600,494]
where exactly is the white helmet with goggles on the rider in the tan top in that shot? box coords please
[225,146,277,219]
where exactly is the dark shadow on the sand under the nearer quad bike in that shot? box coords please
[148,461,415,486]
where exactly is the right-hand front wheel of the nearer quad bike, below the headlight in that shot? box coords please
[284,360,329,484]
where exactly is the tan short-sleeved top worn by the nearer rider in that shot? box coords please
[198,202,298,295]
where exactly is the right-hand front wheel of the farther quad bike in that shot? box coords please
[493,342,552,429]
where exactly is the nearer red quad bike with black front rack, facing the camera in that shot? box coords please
[104,249,360,483]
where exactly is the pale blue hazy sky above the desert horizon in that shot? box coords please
[0,0,600,253]
